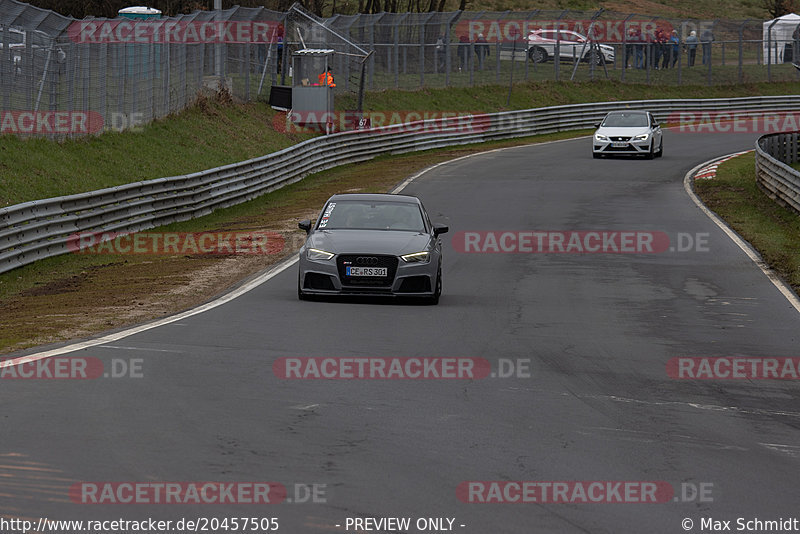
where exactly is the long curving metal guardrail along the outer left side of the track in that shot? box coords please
[0,96,800,273]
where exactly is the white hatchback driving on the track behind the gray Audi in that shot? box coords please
[592,111,664,159]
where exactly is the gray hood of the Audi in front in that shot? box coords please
[308,230,430,256]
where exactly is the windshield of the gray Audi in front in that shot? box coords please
[318,200,425,232]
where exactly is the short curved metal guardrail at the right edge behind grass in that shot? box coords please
[756,132,800,212]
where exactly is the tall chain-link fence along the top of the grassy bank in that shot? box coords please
[0,0,800,137]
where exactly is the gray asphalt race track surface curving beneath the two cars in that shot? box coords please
[0,132,800,534]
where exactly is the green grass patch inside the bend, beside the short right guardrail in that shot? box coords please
[695,153,800,292]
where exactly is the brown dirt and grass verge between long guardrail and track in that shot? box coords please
[0,134,570,353]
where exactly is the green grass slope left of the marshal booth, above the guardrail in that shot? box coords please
[0,94,316,207]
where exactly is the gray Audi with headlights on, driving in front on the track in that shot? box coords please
[297,193,448,304]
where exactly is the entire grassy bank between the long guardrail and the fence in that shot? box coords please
[0,81,797,207]
